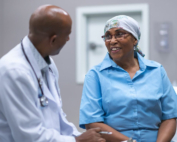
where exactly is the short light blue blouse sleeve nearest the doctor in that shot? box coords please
[79,71,104,128]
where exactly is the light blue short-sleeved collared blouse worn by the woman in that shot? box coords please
[80,53,177,142]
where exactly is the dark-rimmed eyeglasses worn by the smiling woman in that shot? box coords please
[101,32,130,42]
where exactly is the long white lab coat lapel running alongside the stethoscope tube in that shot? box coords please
[22,37,55,102]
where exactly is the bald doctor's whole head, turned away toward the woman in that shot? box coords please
[28,5,72,57]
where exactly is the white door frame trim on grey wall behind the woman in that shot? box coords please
[76,4,149,83]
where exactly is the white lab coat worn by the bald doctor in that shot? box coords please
[0,37,80,142]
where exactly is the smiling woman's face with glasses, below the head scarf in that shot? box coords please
[105,28,137,62]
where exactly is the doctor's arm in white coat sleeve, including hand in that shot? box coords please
[0,69,105,142]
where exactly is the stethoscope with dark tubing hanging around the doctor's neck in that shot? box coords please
[21,41,49,107]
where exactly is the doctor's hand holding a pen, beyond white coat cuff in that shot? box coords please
[76,128,106,142]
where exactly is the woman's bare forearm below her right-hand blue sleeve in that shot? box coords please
[157,118,176,142]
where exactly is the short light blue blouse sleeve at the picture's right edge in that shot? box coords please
[161,67,177,120]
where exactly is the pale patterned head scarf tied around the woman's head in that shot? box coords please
[104,15,145,57]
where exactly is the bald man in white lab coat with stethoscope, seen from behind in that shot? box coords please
[0,5,105,142]
